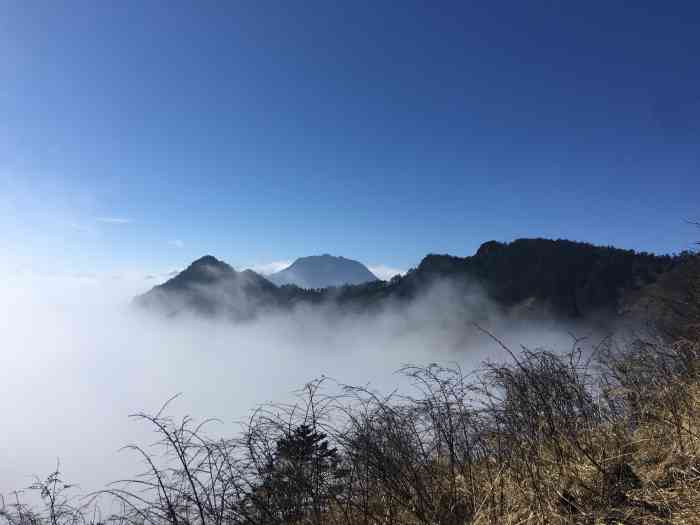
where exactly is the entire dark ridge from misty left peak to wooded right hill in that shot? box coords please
[136,239,683,319]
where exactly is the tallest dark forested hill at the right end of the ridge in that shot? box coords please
[410,239,677,317]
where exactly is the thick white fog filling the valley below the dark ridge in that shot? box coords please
[0,274,600,493]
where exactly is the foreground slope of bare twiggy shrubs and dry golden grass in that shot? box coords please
[0,261,700,525]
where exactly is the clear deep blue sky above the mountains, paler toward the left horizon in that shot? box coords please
[0,0,700,278]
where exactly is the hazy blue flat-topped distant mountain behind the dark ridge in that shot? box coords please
[269,253,377,288]
